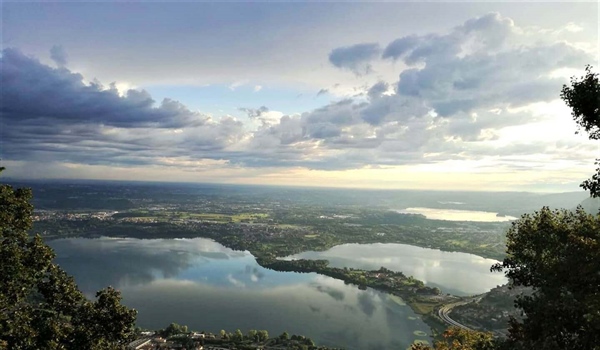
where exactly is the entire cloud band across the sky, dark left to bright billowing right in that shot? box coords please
[0,14,592,178]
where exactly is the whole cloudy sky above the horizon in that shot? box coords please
[0,1,600,192]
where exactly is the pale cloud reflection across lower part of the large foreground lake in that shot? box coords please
[124,276,420,349]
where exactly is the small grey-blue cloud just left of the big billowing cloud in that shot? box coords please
[329,43,381,75]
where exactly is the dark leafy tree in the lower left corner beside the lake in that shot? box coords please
[0,168,136,349]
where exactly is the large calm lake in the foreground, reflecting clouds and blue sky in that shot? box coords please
[49,238,429,350]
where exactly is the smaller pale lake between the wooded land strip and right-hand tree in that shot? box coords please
[286,243,507,295]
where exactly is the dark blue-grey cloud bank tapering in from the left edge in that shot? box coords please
[0,49,205,128]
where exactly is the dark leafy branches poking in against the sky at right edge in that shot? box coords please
[560,65,600,197]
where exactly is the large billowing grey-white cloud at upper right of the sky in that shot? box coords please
[382,13,593,117]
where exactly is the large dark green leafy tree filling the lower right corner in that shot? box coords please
[492,207,600,350]
